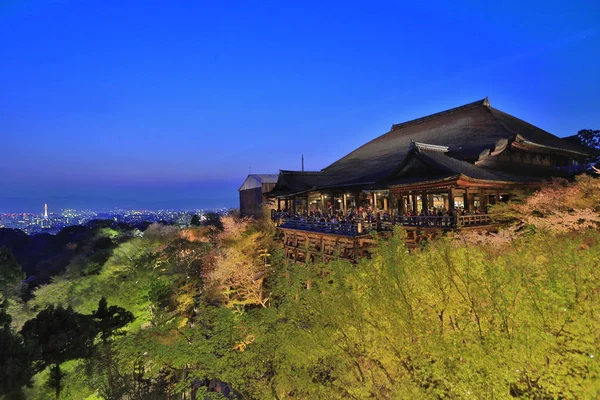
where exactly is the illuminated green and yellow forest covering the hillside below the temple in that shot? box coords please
[0,176,600,400]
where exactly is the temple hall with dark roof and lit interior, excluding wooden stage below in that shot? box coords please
[268,98,589,218]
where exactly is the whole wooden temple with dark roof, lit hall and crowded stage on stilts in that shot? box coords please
[267,98,589,261]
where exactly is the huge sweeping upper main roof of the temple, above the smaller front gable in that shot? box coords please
[319,98,586,186]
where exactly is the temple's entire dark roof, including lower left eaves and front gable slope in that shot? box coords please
[266,98,587,194]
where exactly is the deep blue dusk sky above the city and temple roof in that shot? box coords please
[0,0,600,211]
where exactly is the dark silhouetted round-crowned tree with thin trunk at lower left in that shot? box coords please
[21,305,96,398]
